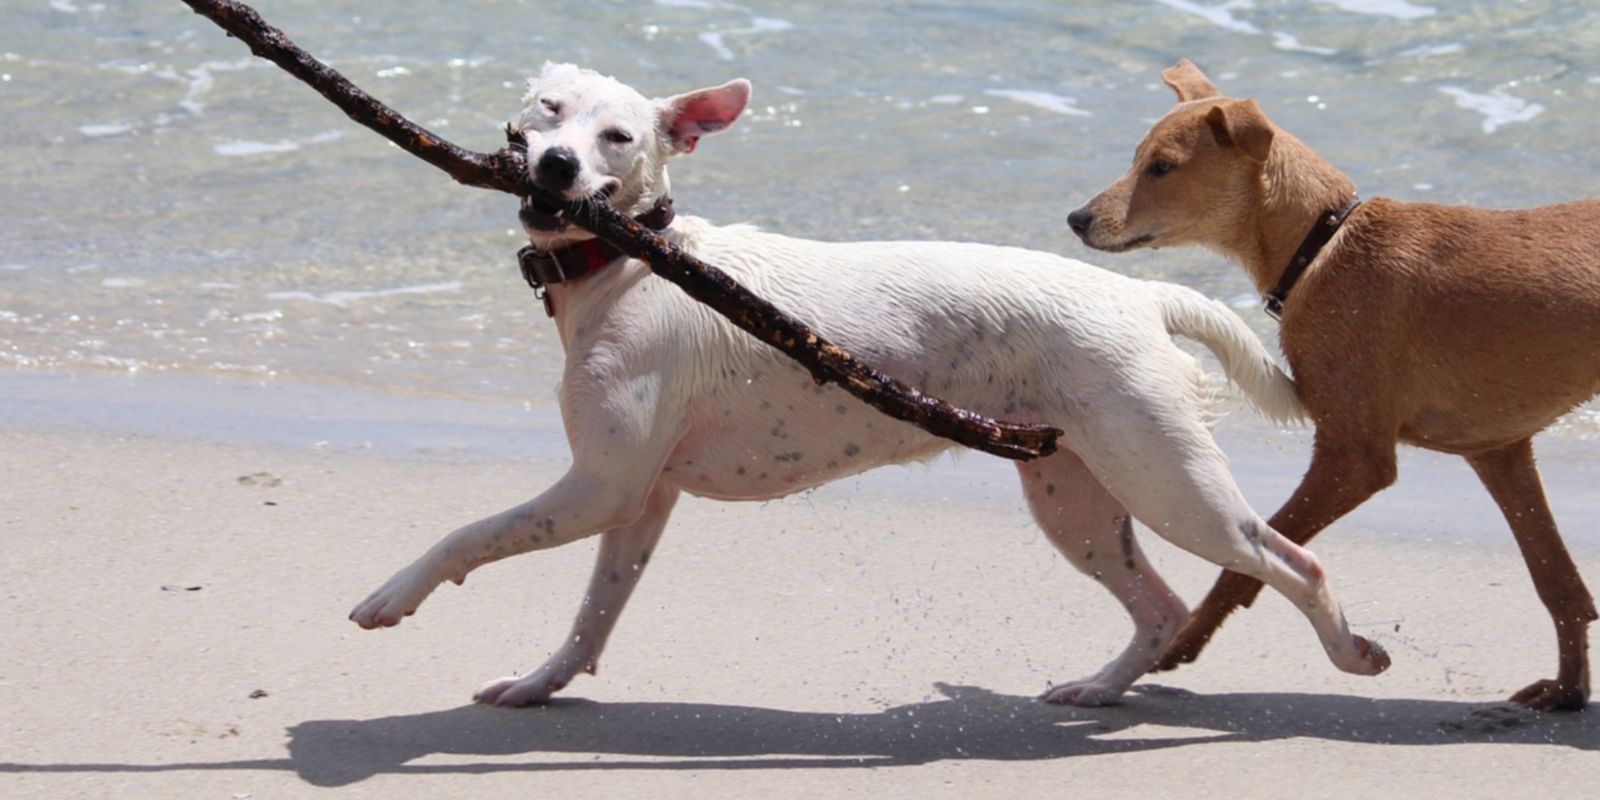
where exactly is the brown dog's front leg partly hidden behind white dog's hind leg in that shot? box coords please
[1150,426,1397,672]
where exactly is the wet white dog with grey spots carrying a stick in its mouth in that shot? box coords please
[350,64,1389,706]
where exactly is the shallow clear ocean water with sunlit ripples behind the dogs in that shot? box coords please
[0,0,1600,438]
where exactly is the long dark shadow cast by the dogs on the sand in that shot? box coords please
[278,685,1600,787]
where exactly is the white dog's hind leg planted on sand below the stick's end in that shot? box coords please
[1018,451,1189,706]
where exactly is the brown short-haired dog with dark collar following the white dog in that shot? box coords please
[1069,61,1600,709]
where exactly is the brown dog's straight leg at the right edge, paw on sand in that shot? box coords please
[1467,438,1595,710]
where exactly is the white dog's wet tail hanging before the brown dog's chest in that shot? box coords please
[1162,283,1306,422]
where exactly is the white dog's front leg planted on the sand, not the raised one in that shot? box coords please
[474,485,678,706]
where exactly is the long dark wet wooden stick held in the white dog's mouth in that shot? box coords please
[175,0,1061,461]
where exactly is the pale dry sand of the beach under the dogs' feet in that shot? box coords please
[0,374,1600,798]
